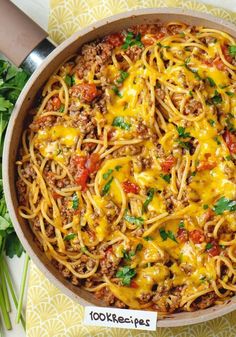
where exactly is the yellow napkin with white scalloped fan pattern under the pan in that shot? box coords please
[26,0,236,337]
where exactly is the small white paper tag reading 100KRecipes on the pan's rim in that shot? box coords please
[84,306,157,331]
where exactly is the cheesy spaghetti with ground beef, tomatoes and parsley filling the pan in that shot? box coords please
[17,22,236,313]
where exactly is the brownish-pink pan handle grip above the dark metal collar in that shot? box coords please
[0,0,48,66]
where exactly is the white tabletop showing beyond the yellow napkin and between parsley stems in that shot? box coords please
[0,0,236,337]
